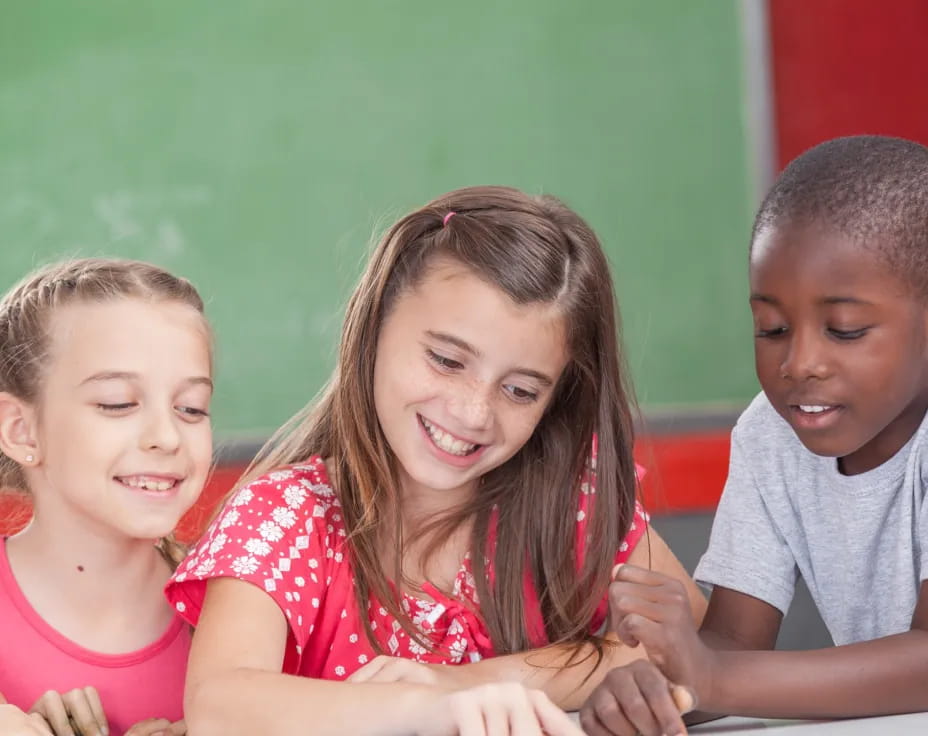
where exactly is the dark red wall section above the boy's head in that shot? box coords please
[769,0,928,168]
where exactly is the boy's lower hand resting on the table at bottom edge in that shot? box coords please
[580,659,696,736]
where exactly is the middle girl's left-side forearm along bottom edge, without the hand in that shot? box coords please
[185,669,442,736]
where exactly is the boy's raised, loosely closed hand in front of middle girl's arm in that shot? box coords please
[609,565,717,706]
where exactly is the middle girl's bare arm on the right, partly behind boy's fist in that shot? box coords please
[358,529,706,710]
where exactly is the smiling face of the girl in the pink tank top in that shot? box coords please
[27,298,212,539]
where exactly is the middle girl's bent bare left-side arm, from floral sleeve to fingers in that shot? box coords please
[184,578,582,736]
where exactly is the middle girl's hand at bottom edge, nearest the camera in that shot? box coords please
[415,682,583,736]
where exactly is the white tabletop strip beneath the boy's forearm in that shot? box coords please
[689,713,928,736]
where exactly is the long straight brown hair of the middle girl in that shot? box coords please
[245,187,636,654]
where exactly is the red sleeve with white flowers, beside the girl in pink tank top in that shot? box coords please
[165,470,342,651]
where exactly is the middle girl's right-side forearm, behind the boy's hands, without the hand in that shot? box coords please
[459,639,647,710]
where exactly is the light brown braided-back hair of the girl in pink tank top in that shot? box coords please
[0,258,210,567]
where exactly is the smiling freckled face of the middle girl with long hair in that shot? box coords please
[374,258,568,505]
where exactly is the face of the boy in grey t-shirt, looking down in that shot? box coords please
[750,223,928,475]
